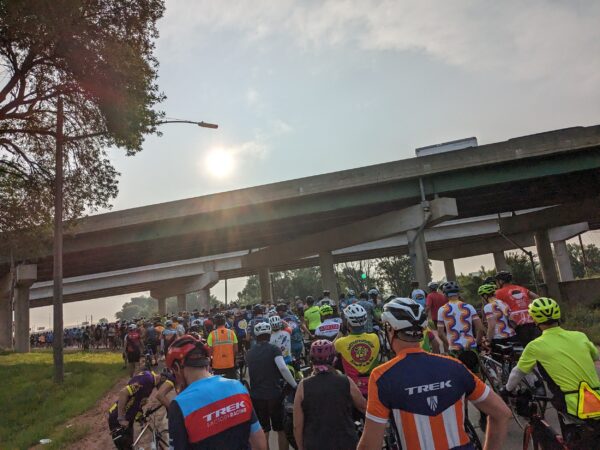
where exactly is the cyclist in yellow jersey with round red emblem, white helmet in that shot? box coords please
[334,304,381,397]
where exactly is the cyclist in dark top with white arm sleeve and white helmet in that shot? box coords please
[246,322,297,448]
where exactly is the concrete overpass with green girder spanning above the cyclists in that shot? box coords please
[0,126,600,352]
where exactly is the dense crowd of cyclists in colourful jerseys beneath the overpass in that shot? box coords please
[109,272,600,450]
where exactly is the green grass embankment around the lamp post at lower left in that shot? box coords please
[0,351,124,449]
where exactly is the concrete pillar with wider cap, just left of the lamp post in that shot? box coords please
[14,264,37,353]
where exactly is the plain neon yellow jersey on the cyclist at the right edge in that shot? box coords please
[517,327,600,415]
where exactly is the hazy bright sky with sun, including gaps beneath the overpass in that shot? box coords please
[32,0,600,324]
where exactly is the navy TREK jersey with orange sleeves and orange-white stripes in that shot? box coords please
[366,348,490,450]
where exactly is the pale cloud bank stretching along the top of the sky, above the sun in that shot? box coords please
[161,0,600,85]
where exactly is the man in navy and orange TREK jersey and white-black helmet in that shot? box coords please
[358,298,511,450]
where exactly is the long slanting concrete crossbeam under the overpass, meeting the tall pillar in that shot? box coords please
[242,198,458,267]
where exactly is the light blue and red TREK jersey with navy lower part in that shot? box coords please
[169,376,260,449]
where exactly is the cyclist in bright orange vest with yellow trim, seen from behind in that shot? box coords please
[206,313,238,380]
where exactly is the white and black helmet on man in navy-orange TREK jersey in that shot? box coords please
[381,297,427,342]
